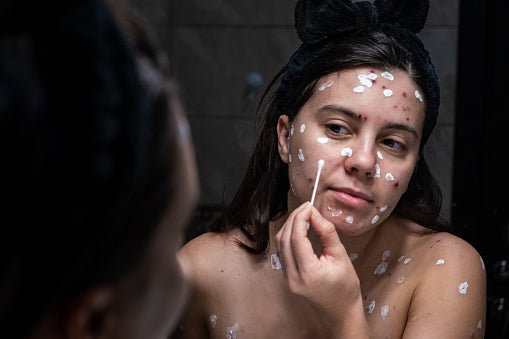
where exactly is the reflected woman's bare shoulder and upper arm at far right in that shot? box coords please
[405,233,486,338]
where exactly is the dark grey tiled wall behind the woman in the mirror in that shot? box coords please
[124,0,459,217]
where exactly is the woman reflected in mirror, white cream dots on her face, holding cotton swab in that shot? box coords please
[178,0,486,338]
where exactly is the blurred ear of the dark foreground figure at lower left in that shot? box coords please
[54,288,115,339]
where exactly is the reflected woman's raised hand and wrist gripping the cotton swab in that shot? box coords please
[276,202,369,338]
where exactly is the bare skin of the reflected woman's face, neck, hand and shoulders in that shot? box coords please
[176,67,486,338]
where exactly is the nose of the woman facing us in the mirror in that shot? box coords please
[342,141,376,178]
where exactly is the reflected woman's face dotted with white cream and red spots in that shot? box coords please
[278,67,425,236]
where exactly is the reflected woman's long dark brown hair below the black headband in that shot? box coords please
[211,31,448,254]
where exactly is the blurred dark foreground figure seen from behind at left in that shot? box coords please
[0,0,197,339]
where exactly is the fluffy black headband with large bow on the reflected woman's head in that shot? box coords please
[278,0,440,144]
